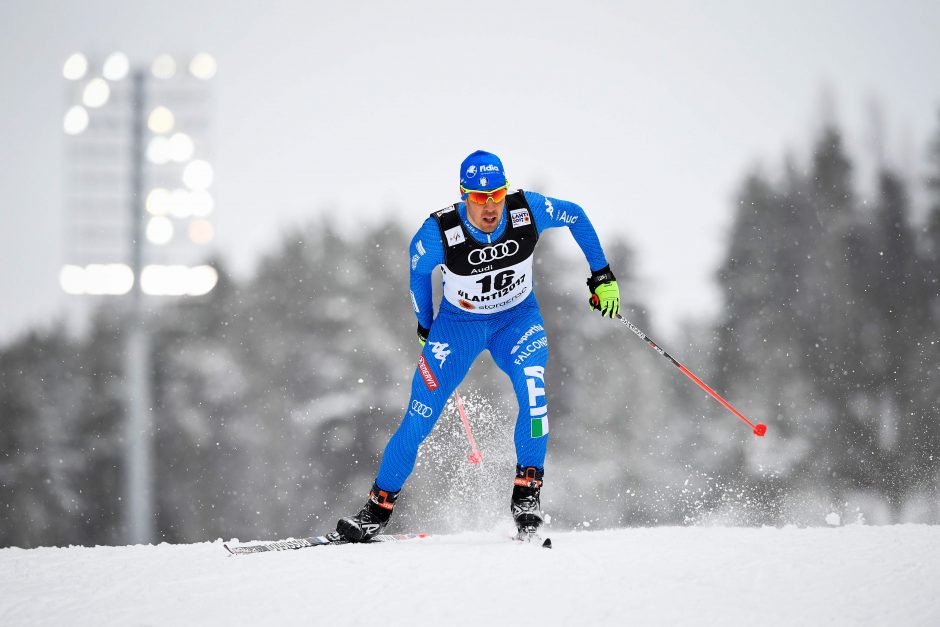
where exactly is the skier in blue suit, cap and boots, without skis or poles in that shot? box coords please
[336,150,620,542]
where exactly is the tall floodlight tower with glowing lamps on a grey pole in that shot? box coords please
[59,52,218,544]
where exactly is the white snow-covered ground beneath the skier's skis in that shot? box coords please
[0,525,940,627]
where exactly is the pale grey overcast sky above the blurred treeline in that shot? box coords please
[0,0,940,341]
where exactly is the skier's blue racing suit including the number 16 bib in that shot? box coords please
[375,190,607,492]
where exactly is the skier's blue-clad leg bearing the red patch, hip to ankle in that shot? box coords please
[375,314,486,492]
